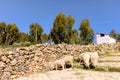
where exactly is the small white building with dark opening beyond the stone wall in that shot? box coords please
[96,33,116,44]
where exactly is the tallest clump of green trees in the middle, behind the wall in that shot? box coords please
[50,13,77,44]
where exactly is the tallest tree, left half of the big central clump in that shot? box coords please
[50,13,66,44]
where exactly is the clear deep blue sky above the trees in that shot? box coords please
[0,0,120,34]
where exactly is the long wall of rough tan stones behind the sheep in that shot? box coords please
[0,43,120,80]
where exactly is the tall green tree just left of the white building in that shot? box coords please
[79,19,94,44]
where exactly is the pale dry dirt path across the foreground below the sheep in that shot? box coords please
[14,69,120,80]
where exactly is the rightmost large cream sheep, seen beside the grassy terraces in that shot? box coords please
[88,52,99,68]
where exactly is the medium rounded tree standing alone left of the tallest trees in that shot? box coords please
[30,23,43,43]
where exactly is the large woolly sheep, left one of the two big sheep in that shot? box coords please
[78,53,90,68]
